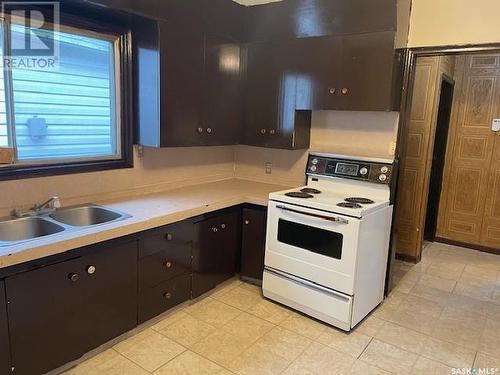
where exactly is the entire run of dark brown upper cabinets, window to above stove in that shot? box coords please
[131,0,400,149]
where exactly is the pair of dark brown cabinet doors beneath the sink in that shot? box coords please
[6,241,137,374]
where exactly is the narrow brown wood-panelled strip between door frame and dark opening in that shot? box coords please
[396,57,454,260]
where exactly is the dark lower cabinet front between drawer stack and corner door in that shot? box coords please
[192,211,241,297]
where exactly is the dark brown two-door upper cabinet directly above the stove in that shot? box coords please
[294,31,398,111]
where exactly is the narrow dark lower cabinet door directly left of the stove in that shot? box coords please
[241,208,267,280]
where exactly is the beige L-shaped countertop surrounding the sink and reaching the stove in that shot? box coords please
[0,179,287,268]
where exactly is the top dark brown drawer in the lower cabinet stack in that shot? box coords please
[139,220,193,258]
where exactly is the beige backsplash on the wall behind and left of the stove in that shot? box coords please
[235,111,399,186]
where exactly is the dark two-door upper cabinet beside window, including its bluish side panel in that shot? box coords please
[135,21,241,147]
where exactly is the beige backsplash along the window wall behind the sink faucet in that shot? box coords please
[0,146,234,216]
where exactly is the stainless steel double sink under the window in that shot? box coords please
[0,205,130,247]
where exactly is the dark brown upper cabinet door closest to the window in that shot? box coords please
[159,21,205,146]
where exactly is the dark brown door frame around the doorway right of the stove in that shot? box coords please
[389,43,500,263]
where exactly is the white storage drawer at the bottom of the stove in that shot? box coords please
[262,268,353,331]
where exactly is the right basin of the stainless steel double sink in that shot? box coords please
[50,206,127,227]
